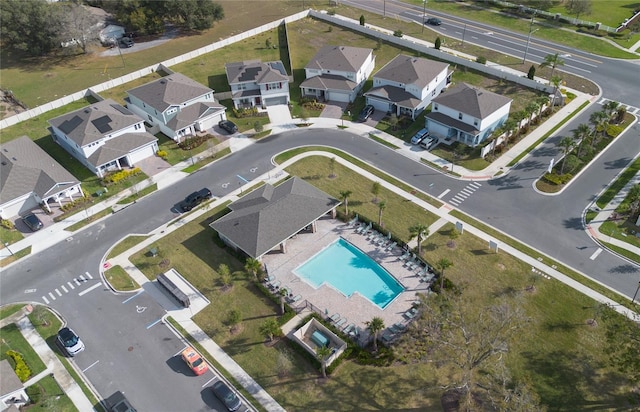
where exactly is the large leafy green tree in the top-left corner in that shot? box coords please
[0,0,64,56]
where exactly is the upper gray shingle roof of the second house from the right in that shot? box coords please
[373,54,449,89]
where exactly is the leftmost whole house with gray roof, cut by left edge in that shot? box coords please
[0,136,83,219]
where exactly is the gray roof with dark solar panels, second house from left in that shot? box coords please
[49,99,142,146]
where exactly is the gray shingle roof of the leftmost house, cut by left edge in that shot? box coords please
[0,136,80,203]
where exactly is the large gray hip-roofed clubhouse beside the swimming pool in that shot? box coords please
[210,177,340,259]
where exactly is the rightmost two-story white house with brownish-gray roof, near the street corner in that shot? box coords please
[425,83,512,146]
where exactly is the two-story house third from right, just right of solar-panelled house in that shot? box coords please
[300,46,376,102]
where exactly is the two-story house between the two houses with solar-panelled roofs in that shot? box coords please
[125,73,227,142]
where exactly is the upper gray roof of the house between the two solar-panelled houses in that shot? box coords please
[127,73,213,112]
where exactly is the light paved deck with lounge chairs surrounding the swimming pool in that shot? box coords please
[262,217,436,342]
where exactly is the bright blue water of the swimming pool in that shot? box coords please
[295,239,404,309]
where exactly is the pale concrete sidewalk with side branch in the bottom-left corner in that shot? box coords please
[0,306,94,411]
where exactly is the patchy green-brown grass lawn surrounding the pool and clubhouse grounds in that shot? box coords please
[131,158,630,411]
